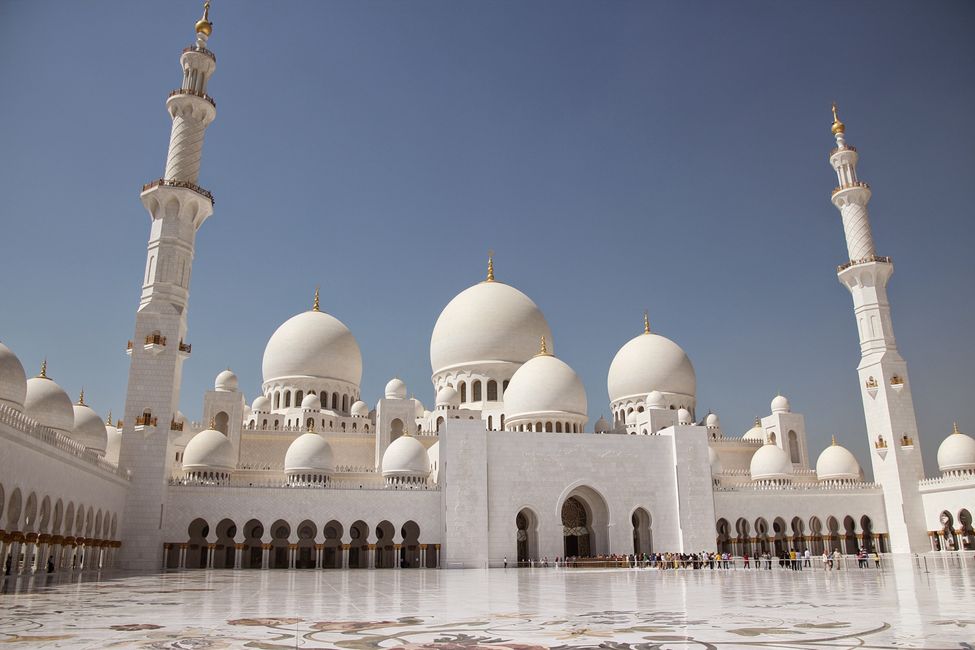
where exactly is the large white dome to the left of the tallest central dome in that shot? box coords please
[262,311,362,387]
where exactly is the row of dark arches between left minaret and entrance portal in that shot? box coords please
[163,519,440,569]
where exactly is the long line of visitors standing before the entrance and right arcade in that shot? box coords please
[504,547,880,571]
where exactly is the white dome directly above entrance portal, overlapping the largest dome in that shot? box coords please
[504,354,587,421]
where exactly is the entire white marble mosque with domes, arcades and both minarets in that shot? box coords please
[0,7,975,572]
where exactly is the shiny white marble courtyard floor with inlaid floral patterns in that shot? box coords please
[0,558,975,650]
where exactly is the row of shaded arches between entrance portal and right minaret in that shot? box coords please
[716,515,889,556]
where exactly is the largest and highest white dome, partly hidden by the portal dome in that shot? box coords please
[430,281,554,374]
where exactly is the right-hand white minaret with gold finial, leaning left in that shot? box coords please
[829,104,930,553]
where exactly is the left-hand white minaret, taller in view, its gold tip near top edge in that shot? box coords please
[120,2,217,570]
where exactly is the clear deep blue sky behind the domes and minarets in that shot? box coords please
[0,0,975,472]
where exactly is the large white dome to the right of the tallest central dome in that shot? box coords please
[606,333,697,402]
